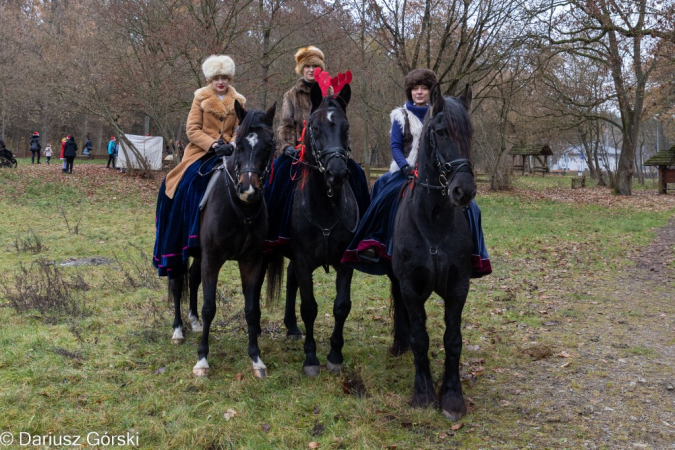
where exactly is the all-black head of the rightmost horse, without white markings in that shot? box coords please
[420,84,476,206]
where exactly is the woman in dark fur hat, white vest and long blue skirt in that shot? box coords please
[342,69,492,278]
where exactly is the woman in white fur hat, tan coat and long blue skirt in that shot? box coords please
[153,55,246,276]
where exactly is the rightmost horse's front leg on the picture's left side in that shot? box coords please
[399,268,436,407]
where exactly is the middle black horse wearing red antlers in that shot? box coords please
[267,83,359,376]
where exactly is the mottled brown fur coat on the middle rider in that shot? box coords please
[277,78,312,151]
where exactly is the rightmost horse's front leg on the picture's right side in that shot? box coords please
[441,278,469,420]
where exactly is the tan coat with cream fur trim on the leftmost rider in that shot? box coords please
[166,85,246,198]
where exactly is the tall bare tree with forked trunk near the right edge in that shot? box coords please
[535,0,675,195]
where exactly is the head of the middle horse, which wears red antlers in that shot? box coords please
[304,83,352,191]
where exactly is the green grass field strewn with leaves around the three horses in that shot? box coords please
[0,163,675,449]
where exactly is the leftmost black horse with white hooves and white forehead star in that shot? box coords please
[170,101,276,378]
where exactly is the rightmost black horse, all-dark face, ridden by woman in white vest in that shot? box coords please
[389,85,476,420]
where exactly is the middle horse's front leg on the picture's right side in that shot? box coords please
[326,264,354,374]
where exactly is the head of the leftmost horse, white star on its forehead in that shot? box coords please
[232,100,277,203]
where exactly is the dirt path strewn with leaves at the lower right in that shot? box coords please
[500,219,675,449]
